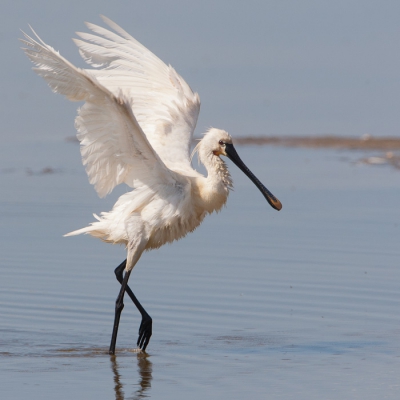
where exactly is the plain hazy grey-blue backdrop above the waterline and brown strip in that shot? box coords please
[0,0,400,140]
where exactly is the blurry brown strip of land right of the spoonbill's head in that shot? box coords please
[234,135,400,150]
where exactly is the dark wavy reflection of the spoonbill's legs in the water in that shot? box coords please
[110,354,153,400]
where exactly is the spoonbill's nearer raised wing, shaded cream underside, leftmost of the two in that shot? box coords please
[22,28,179,197]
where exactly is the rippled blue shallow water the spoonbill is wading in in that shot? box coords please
[0,141,400,399]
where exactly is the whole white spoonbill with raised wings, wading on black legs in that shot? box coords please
[21,17,282,354]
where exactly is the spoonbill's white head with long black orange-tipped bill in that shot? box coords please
[193,128,282,211]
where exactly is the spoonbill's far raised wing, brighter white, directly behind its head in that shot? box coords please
[74,17,200,173]
